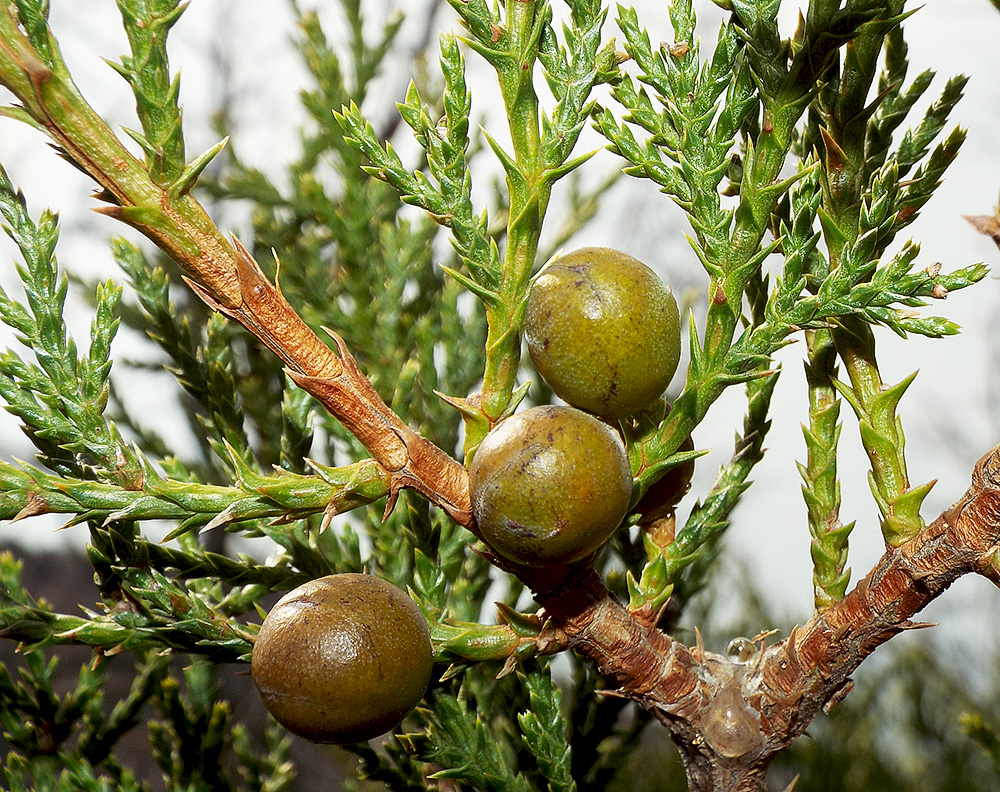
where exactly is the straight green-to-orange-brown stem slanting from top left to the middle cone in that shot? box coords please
[0,7,470,524]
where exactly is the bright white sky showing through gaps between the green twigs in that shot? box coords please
[0,0,1000,655]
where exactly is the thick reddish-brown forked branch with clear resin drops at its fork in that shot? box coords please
[522,446,1000,792]
